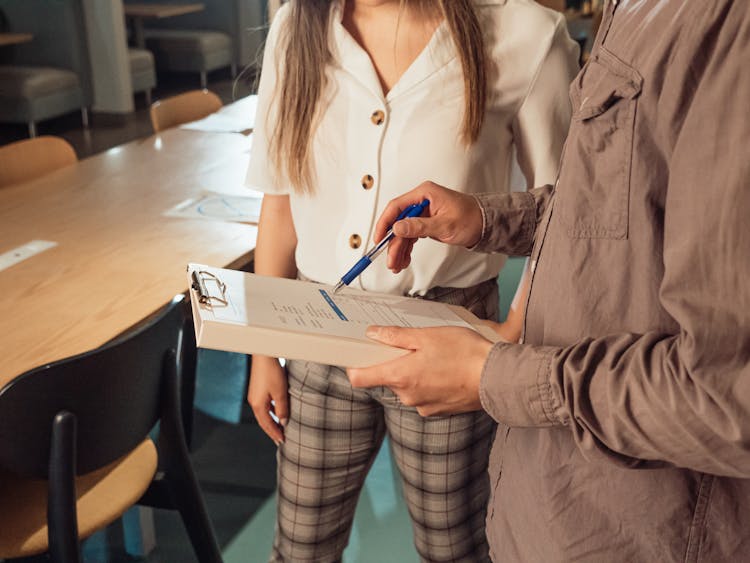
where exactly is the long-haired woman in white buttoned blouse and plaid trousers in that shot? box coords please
[248,0,577,562]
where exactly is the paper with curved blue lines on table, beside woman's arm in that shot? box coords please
[164,190,263,223]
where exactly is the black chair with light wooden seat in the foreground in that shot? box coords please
[0,295,221,563]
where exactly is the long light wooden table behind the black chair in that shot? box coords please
[0,128,257,388]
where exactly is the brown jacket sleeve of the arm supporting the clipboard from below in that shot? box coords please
[480,2,750,478]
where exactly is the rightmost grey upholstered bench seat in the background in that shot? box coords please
[145,29,235,88]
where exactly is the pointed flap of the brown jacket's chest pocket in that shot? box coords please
[571,48,643,121]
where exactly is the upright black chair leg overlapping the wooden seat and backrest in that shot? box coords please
[47,411,81,563]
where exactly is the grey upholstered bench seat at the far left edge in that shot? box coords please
[0,65,87,137]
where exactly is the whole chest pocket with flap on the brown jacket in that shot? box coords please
[556,47,643,239]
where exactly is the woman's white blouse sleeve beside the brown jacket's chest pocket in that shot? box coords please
[513,15,578,188]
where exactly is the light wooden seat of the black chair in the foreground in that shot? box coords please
[0,438,158,558]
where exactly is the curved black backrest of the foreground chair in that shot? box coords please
[0,295,194,479]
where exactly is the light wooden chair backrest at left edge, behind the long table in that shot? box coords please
[0,137,78,188]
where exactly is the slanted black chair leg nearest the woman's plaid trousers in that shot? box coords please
[159,350,222,563]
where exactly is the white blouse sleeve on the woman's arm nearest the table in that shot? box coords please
[245,4,292,195]
